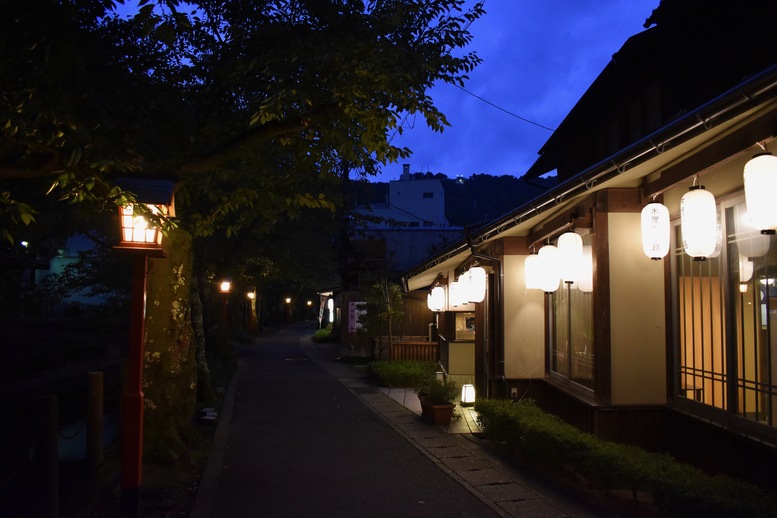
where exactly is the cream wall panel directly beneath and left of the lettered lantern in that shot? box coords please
[609,213,669,405]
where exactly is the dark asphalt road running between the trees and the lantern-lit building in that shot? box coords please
[194,327,497,518]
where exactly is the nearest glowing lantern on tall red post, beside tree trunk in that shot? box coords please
[114,178,175,516]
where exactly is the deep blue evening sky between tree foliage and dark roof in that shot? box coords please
[374,0,659,181]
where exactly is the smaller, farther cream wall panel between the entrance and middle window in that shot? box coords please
[502,256,545,378]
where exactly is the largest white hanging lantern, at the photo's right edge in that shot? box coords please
[744,153,777,234]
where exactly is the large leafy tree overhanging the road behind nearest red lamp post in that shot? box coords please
[0,0,483,472]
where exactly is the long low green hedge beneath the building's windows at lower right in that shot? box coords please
[475,399,777,517]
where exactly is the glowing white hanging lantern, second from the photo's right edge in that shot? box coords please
[680,185,718,261]
